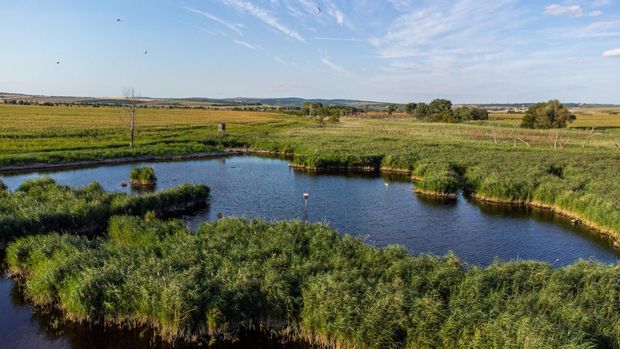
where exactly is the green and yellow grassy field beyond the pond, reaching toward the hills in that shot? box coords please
[0,105,620,241]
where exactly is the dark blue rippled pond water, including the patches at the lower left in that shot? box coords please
[0,156,618,348]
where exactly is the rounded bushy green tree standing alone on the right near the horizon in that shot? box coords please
[521,100,576,129]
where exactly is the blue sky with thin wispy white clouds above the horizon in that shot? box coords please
[0,0,620,104]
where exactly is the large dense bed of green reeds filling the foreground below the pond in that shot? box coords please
[7,217,620,348]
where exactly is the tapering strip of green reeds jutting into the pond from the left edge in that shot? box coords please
[0,178,209,242]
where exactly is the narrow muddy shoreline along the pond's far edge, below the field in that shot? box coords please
[0,148,620,247]
